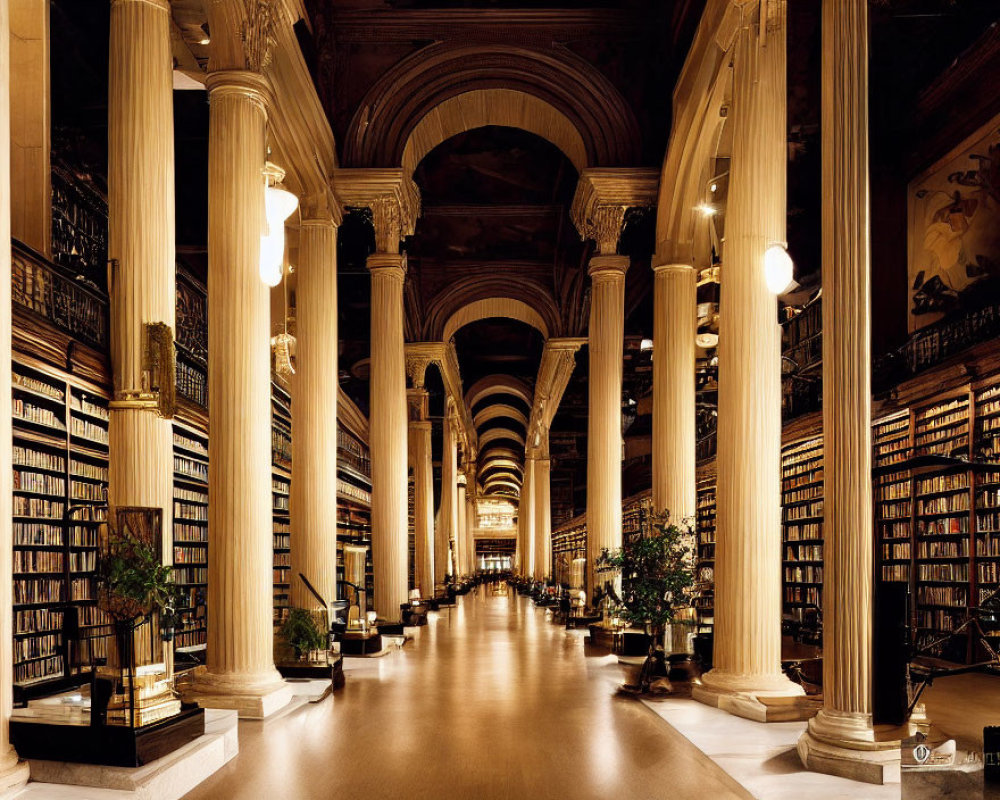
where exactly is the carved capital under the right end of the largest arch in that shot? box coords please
[570,167,660,255]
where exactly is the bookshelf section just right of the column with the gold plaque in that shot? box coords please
[174,419,208,651]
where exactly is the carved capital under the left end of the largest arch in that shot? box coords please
[333,168,420,253]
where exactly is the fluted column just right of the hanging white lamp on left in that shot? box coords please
[291,206,339,608]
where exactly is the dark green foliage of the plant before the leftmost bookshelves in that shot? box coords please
[96,527,178,622]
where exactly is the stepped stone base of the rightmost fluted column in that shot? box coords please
[797,709,901,785]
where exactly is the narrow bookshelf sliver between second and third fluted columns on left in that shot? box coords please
[271,381,292,625]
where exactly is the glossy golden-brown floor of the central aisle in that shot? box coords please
[187,587,749,800]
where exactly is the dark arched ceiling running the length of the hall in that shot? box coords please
[318,0,698,521]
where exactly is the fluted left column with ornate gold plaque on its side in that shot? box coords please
[108,0,176,563]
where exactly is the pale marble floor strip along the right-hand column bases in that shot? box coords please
[643,698,900,800]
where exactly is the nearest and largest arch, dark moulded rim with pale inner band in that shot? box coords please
[343,42,642,170]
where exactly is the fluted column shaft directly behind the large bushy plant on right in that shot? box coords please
[653,264,698,522]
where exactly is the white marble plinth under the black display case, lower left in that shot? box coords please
[15,709,240,800]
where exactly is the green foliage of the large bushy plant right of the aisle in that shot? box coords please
[597,512,694,633]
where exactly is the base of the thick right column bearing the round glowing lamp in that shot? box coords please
[691,669,817,722]
